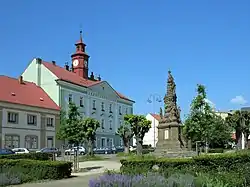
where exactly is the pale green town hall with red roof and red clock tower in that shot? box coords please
[22,33,135,147]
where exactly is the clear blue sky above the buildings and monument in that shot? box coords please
[0,0,250,116]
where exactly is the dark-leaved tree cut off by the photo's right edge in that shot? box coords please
[226,110,250,149]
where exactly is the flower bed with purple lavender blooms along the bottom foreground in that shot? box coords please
[89,173,227,187]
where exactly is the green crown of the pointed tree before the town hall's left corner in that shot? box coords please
[57,103,84,146]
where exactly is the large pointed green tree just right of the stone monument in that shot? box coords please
[183,84,230,152]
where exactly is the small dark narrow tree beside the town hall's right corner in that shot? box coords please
[116,121,133,153]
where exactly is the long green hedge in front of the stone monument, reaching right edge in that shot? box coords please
[121,152,250,187]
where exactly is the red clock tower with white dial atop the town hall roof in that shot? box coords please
[71,31,89,79]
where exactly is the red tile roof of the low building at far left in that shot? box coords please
[0,75,60,110]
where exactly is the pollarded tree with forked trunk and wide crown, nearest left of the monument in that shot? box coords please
[124,114,151,155]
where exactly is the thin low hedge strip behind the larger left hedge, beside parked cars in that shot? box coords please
[0,153,52,160]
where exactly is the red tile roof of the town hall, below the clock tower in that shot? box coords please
[42,61,134,102]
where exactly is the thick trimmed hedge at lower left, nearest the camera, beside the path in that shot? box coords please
[0,159,72,183]
